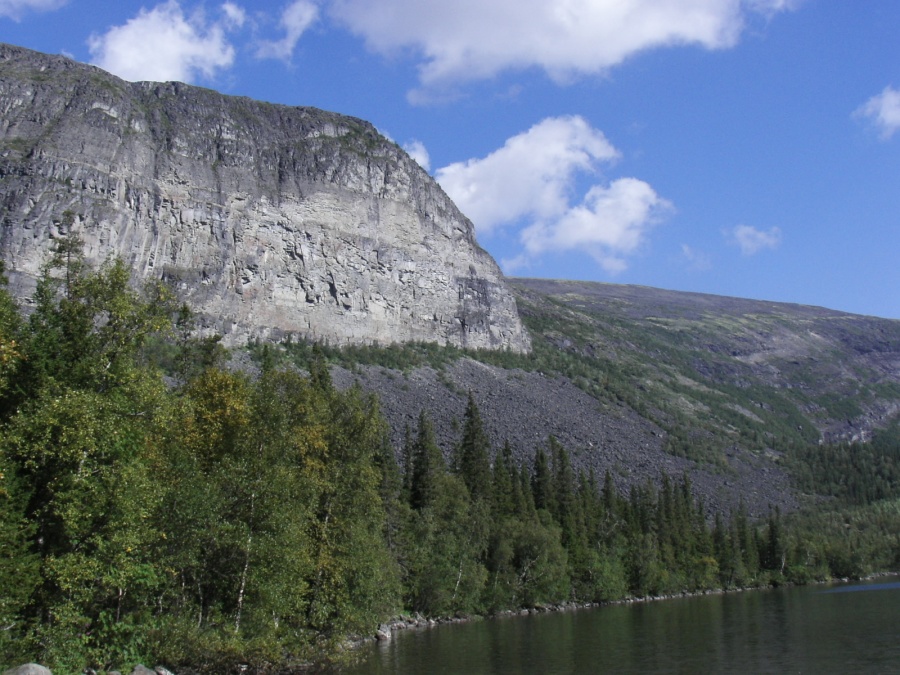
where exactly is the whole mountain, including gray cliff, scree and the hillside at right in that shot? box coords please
[0,45,900,516]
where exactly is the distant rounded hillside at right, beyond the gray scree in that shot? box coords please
[513,279,900,460]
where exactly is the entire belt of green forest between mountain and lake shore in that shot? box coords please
[0,240,900,673]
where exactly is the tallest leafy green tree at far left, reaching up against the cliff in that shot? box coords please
[0,240,179,667]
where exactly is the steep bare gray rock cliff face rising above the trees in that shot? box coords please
[0,45,530,351]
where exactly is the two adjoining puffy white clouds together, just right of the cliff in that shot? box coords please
[436,116,671,273]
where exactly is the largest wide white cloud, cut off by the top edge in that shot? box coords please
[331,0,796,87]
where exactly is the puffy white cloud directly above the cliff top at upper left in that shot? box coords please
[88,0,244,82]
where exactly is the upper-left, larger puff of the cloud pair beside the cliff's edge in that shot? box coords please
[435,116,619,235]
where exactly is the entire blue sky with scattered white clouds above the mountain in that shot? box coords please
[0,0,900,319]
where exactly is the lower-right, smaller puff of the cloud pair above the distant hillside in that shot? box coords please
[521,178,671,274]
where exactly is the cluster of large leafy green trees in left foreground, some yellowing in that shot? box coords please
[0,240,399,672]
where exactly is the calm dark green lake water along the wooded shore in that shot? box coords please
[347,578,900,675]
